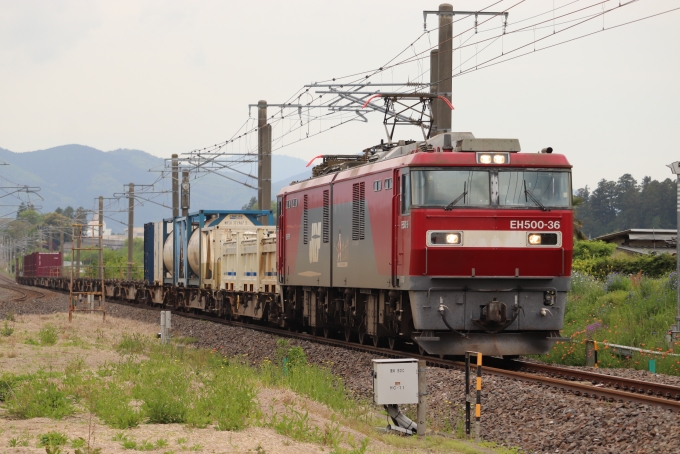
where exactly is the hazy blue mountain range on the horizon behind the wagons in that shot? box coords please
[0,145,311,232]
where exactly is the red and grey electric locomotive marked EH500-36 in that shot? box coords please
[277,133,573,355]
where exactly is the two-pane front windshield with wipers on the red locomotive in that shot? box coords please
[412,168,571,209]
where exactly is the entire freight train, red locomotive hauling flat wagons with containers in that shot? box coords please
[15,133,573,356]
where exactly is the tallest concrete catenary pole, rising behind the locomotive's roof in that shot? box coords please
[437,3,453,133]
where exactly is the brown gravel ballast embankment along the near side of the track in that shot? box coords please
[0,282,680,453]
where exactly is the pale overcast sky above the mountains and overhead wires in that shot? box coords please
[0,0,680,192]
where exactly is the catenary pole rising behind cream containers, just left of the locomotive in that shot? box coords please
[257,101,272,225]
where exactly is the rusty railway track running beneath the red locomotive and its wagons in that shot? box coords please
[11,276,680,414]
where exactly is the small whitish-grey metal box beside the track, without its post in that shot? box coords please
[373,358,418,405]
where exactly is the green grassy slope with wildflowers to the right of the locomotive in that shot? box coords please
[541,273,680,375]
